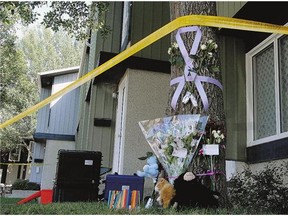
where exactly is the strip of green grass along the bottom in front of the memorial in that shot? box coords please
[0,197,271,215]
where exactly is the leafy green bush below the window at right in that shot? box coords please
[228,163,288,214]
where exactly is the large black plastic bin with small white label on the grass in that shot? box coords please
[53,149,102,202]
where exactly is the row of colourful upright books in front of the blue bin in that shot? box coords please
[108,185,140,209]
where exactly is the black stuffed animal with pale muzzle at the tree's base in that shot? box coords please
[172,172,220,210]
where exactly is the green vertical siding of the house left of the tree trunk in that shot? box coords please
[76,2,170,167]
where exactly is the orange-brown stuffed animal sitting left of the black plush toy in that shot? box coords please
[155,178,175,208]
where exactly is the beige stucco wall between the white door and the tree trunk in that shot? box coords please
[123,70,170,174]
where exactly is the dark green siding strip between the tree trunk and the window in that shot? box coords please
[220,36,247,161]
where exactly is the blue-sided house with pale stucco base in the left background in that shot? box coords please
[29,67,79,189]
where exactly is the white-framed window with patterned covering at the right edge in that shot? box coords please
[246,35,288,146]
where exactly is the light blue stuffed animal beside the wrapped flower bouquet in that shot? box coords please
[137,155,159,183]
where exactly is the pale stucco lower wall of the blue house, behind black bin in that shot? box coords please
[41,140,75,189]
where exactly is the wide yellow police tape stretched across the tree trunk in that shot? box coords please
[0,15,288,129]
